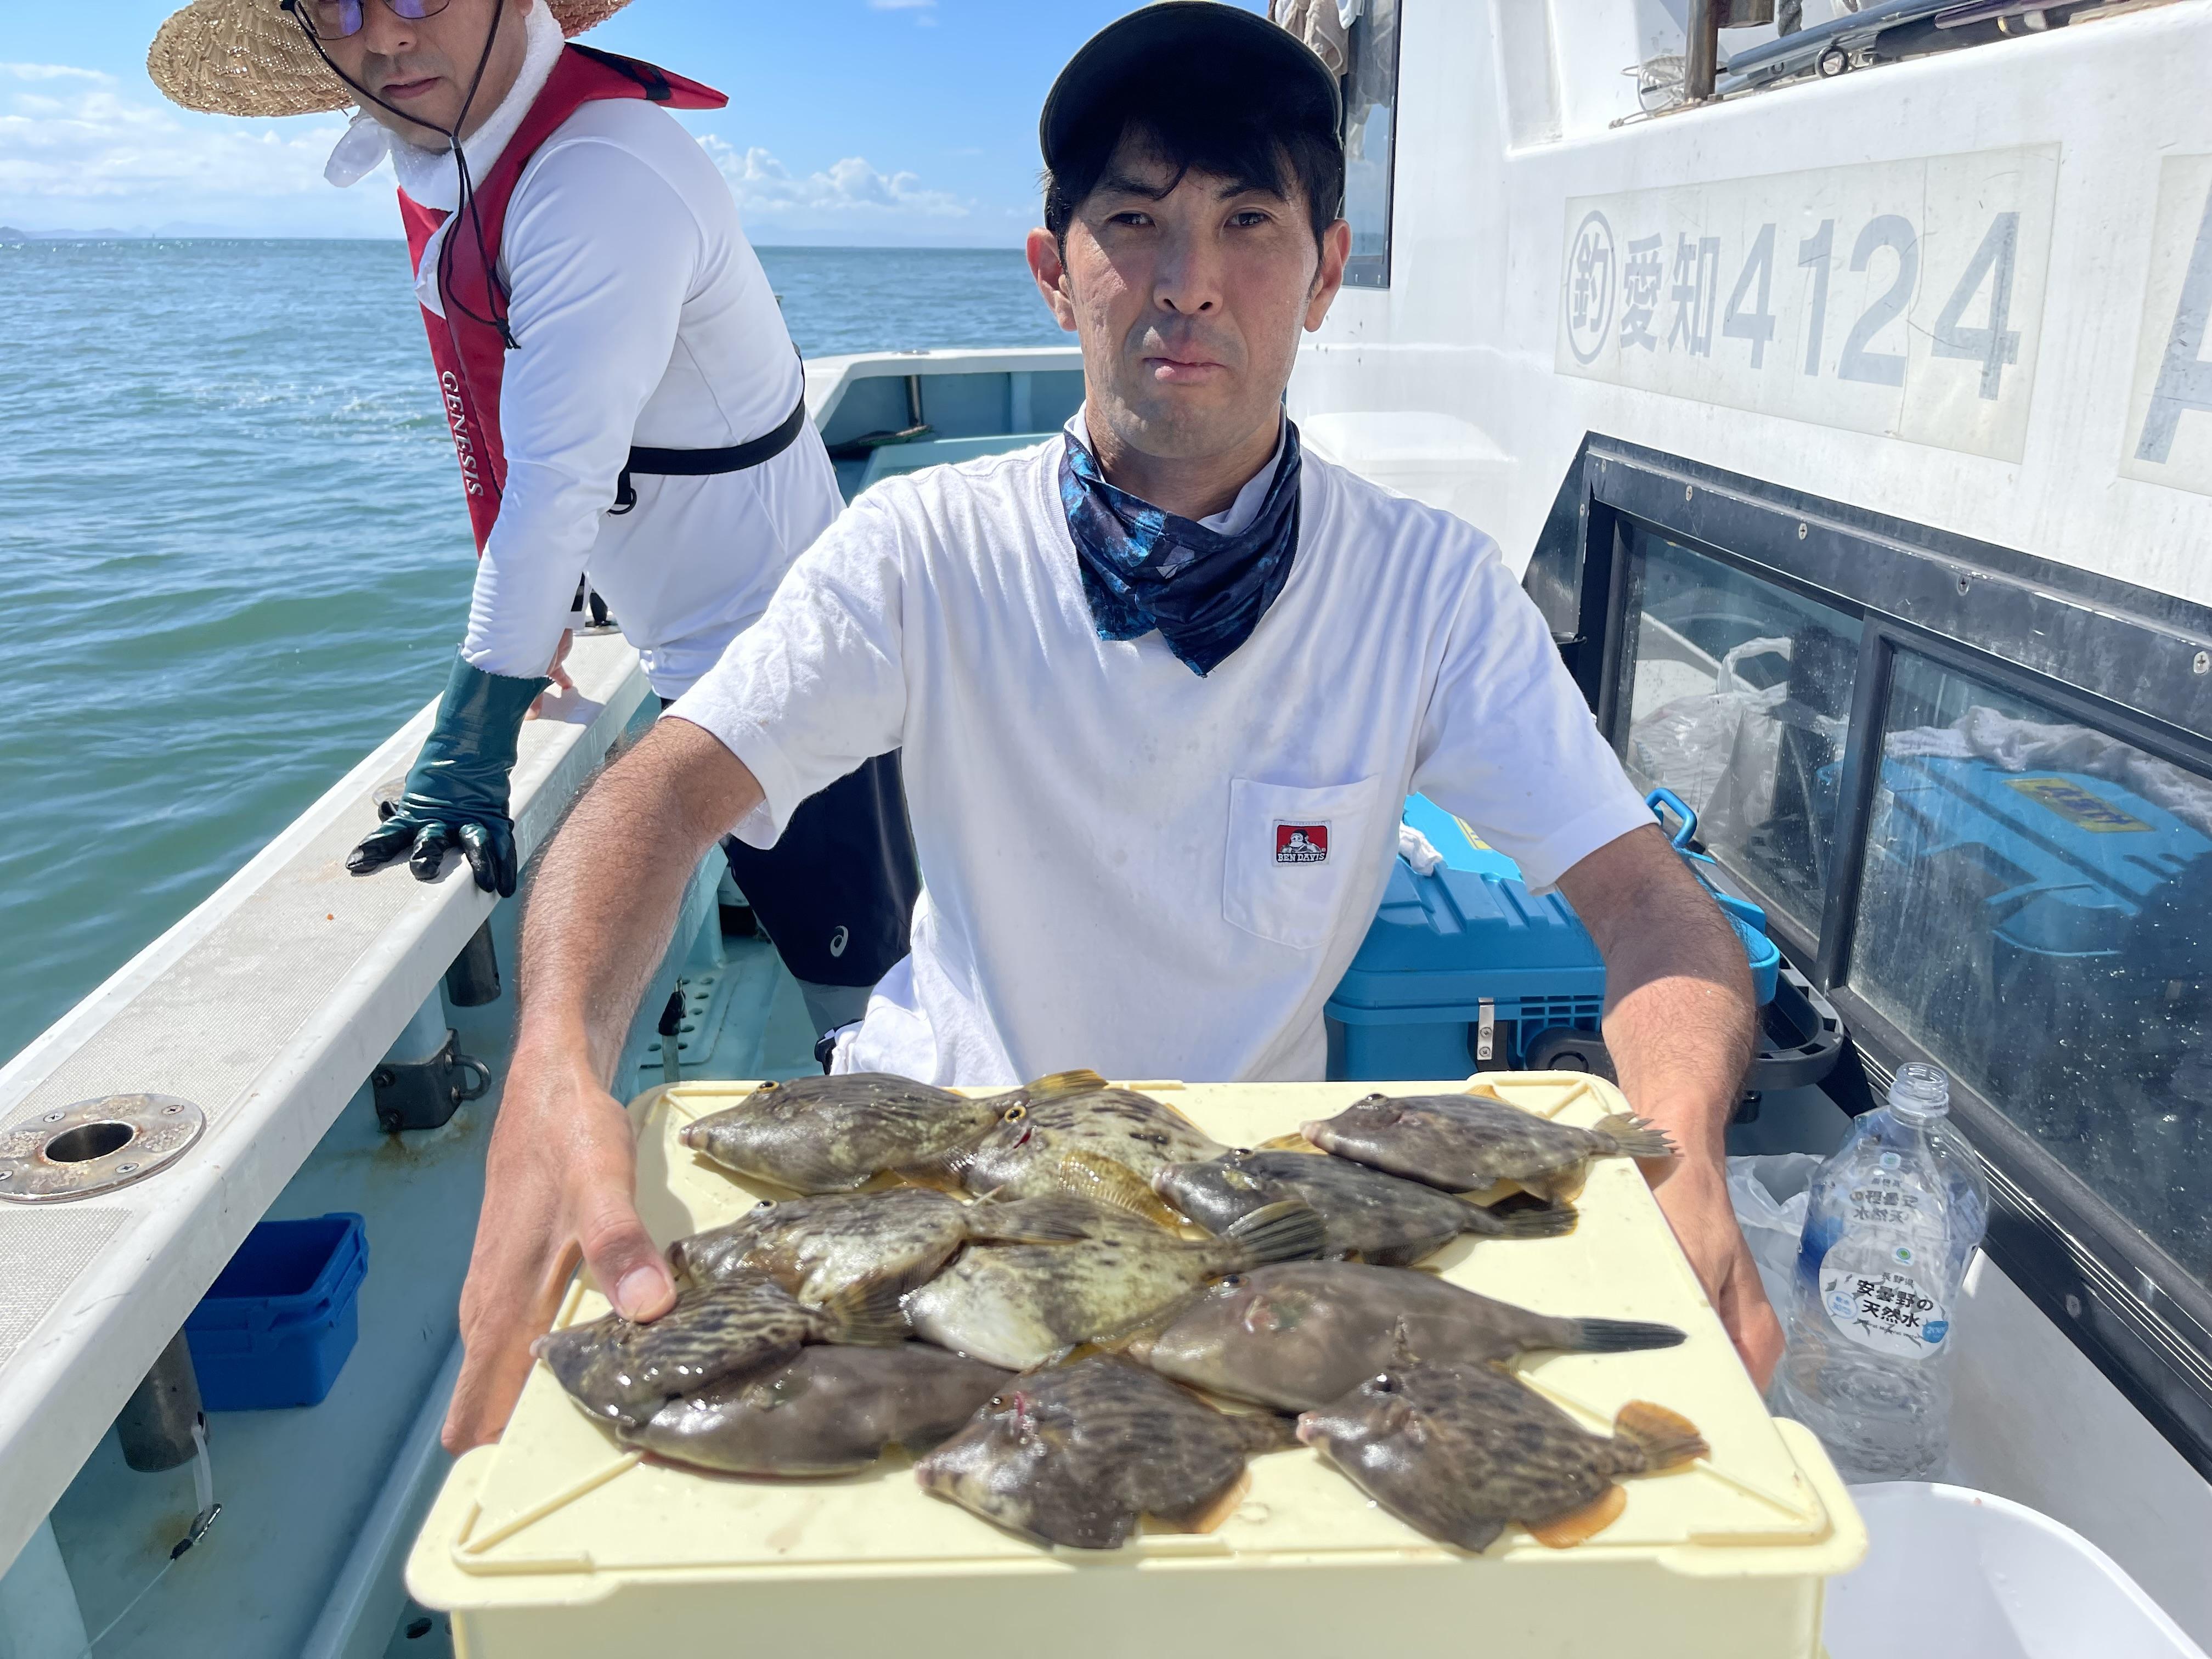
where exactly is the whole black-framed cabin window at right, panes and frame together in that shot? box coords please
[1557,433,2212,1469]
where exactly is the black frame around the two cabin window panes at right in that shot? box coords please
[1537,433,2212,1477]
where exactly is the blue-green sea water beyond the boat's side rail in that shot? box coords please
[0,241,1070,1059]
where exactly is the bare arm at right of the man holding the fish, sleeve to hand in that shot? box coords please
[1560,825,1783,1389]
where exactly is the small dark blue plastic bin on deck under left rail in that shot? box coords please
[184,1212,369,1411]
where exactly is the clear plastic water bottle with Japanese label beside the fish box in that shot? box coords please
[1774,1062,1989,1482]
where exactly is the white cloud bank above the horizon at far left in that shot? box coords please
[0,64,398,236]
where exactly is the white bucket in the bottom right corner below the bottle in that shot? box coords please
[1822,1480,2205,1659]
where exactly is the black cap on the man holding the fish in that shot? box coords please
[1037,0,1345,170]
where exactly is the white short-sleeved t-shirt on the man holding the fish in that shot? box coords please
[673,422,1652,1084]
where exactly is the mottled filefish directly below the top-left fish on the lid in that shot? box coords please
[668,1186,1088,1303]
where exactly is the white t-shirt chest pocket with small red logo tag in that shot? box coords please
[1221,778,1376,951]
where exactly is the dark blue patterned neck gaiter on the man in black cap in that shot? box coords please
[1059,418,1299,679]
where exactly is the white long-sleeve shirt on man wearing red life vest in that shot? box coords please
[349,7,843,697]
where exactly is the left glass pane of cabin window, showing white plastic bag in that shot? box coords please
[1619,524,1860,931]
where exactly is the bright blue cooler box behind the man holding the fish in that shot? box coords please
[1323,789,1781,1082]
